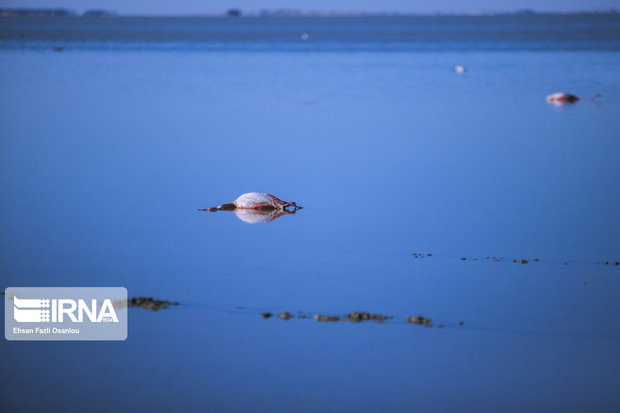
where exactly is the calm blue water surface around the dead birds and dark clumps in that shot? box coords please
[0,15,620,412]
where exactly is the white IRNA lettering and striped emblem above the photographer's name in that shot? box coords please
[13,296,118,323]
